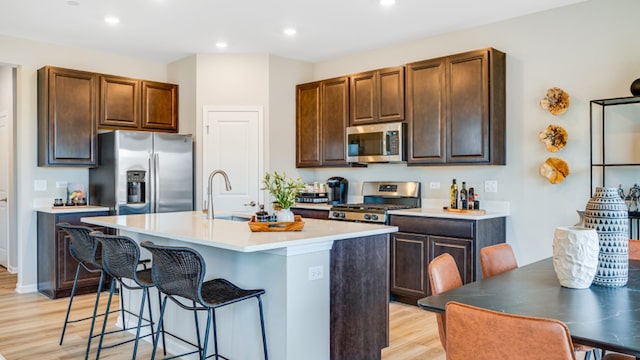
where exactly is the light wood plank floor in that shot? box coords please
[0,267,445,360]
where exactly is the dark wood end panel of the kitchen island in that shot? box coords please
[331,234,389,360]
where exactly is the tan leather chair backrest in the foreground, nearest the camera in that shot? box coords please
[446,302,576,360]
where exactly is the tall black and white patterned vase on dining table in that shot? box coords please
[584,187,629,287]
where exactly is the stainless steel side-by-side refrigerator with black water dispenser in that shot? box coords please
[89,130,194,215]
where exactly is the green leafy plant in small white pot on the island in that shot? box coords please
[262,171,305,221]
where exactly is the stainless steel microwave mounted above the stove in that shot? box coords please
[347,122,405,163]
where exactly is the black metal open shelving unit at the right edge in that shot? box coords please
[589,97,640,239]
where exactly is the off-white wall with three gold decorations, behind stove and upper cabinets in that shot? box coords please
[304,0,640,264]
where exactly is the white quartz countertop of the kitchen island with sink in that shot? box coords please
[82,211,398,252]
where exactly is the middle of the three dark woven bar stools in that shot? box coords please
[90,231,166,359]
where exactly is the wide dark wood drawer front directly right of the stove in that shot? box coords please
[391,215,475,239]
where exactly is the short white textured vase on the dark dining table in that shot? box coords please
[553,226,600,289]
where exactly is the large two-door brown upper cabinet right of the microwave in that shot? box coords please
[406,48,506,165]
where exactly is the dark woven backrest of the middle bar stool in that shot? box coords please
[90,231,141,285]
